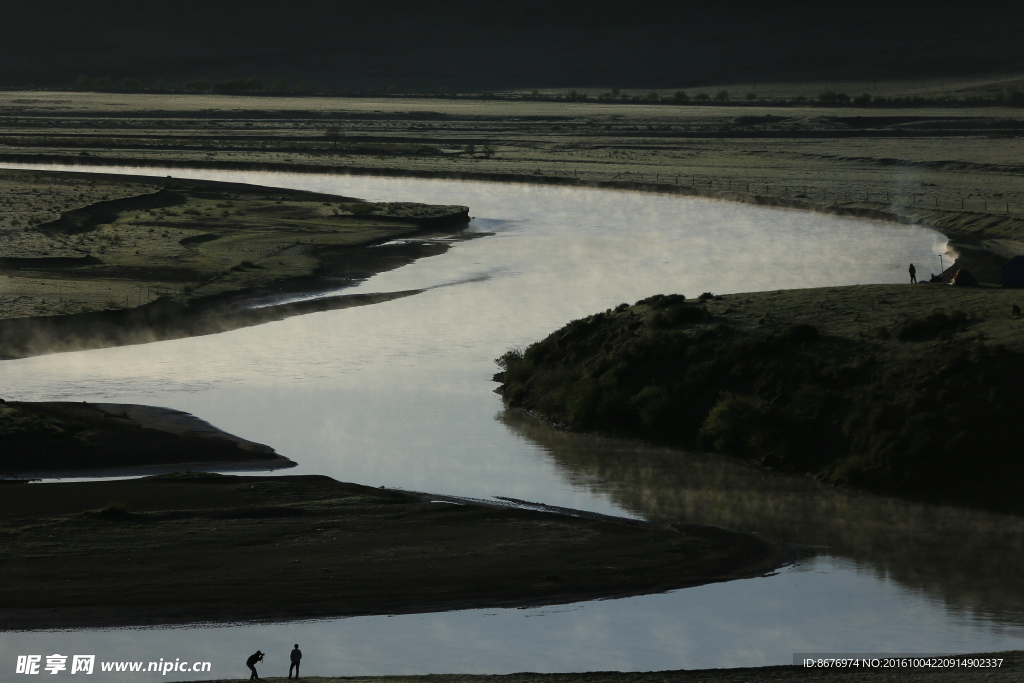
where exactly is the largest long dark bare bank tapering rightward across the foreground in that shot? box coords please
[0,474,788,630]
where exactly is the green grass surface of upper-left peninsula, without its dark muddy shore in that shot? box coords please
[0,171,465,318]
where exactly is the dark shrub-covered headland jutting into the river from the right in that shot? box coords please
[496,284,1024,512]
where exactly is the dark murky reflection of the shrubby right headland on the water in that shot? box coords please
[500,410,1024,624]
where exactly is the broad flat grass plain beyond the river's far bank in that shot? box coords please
[0,91,1024,248]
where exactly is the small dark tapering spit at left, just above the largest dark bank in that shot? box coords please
[0,401,295,479]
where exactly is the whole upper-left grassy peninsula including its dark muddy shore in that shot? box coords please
[0,171,468,357]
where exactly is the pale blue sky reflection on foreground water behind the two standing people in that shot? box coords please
[0,557,1024,680]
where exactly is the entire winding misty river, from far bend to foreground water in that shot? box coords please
[0,163,1024,680]
